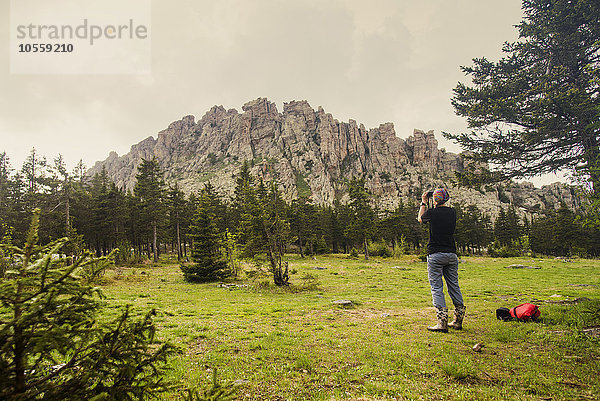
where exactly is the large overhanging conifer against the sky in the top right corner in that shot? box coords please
[445,0,600,194]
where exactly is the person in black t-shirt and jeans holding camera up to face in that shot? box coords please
[417,188,466,333]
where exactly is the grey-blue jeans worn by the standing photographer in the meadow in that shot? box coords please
[427,252,464,308]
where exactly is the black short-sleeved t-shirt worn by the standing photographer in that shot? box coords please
[421,206,456,255]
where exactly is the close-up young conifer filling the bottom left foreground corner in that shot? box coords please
[0,210,171,401]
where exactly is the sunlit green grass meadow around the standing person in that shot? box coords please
[96,256,600,400]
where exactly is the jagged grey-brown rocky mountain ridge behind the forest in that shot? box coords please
[89,98,578,215]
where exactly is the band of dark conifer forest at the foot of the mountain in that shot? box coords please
[0,150,600,263]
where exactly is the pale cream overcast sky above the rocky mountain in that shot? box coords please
[0,0,568,185]
